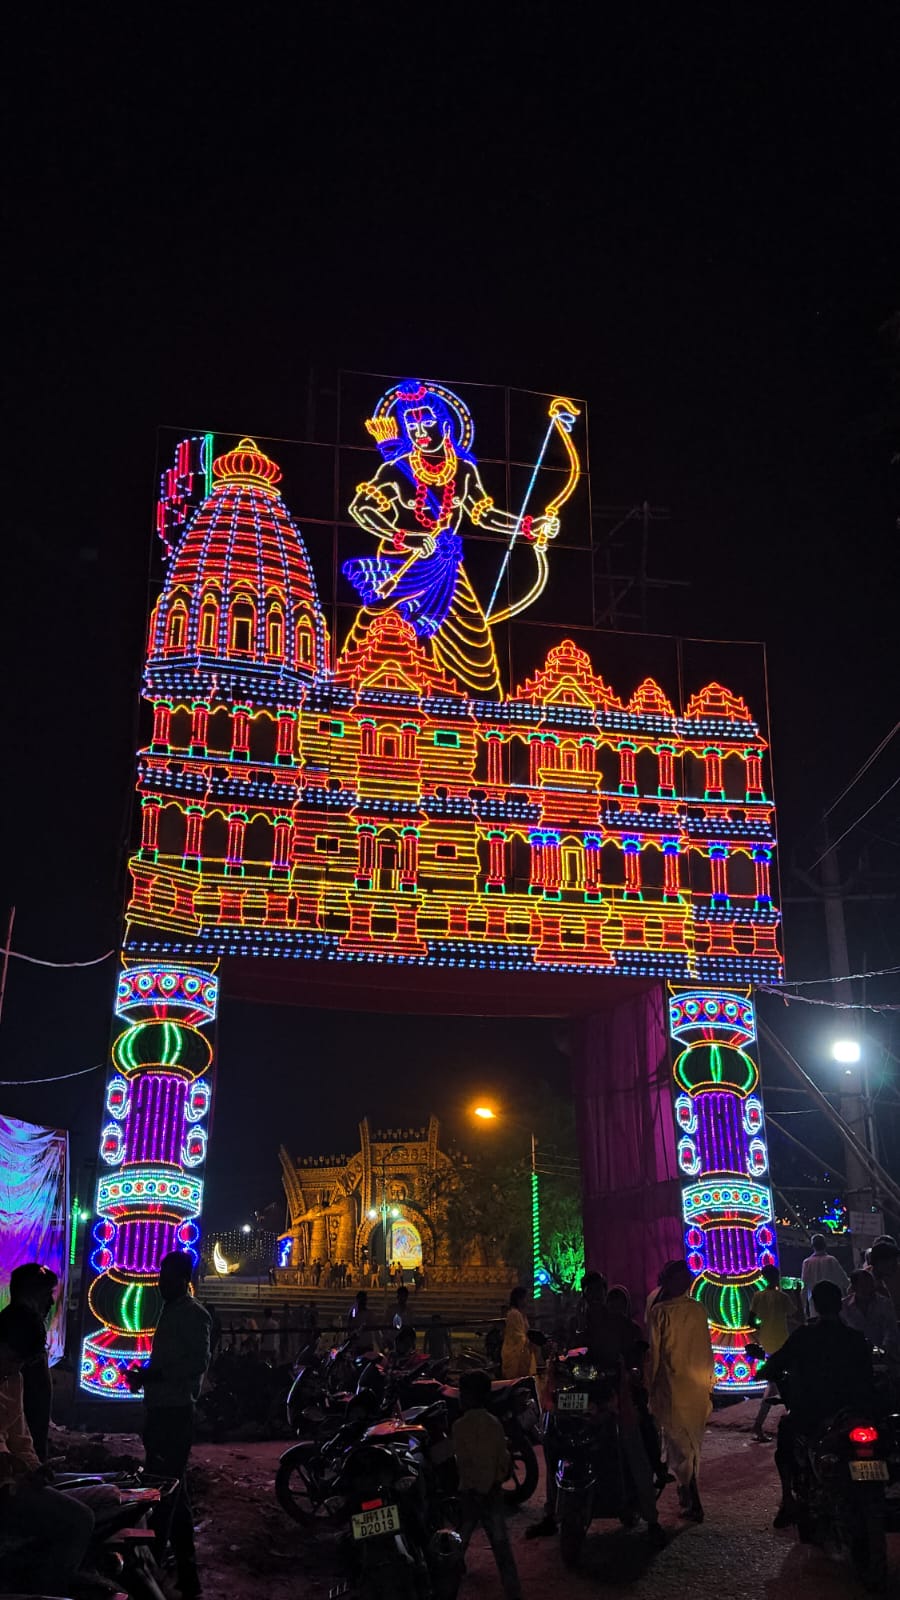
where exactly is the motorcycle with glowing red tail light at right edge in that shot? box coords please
[793,1411,892,1592]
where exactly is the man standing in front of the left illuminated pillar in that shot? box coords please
[128,1250,210,1600]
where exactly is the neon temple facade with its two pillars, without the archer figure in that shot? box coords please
[82,435,781,1397]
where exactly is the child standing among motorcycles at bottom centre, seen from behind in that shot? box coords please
[453,1371,522,1600]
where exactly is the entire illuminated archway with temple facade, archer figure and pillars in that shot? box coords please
[82,374,781,1394]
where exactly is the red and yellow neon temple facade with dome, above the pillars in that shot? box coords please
[128,443,780,981]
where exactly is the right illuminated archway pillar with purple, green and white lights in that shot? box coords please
[668,984,778,1392]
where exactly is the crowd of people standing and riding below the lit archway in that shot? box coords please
[0,1235,900,1600]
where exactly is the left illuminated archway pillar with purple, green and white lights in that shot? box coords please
[82,962,218,1398]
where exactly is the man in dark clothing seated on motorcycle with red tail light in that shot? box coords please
[759,1278,873,1528]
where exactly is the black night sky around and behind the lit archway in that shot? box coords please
[7,9,900,1224]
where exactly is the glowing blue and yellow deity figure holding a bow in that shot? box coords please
[343,381,580,694]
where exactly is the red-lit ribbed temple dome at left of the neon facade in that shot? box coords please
[147,438,328,701]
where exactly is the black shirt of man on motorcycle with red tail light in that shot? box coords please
[759,1317,873,1427]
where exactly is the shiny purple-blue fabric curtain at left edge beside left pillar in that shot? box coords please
[0,1117,69,1366]
